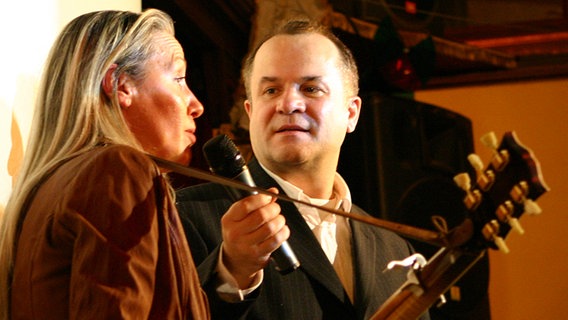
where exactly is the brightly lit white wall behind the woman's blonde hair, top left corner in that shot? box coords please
[0,0,142,208]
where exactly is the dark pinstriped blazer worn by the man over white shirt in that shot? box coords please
[177,159,426,320]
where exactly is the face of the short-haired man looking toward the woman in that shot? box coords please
[245,33,360,171]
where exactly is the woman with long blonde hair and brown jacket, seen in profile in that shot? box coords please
[0,10,209,319]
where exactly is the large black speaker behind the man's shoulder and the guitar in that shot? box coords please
[338,93,490,320]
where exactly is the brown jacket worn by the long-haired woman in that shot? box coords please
[11,146,209,320]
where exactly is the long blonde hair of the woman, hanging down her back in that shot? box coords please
[0,9,174,320]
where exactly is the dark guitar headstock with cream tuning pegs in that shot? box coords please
[454,132,549,252]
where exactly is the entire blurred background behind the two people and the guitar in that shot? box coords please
[0,0,568,320]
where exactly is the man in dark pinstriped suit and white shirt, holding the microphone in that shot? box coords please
[178,21,426,320]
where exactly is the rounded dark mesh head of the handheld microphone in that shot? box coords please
[203,134,246,177]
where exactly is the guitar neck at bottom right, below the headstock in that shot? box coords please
[371,248,486,320]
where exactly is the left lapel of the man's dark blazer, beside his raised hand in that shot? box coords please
[248,159,349,303]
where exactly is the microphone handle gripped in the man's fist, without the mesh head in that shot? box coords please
[226,170,300,274]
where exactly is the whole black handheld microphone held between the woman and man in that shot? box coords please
[203,134,300,274]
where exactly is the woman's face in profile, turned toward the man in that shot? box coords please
[123,33,203,164]
